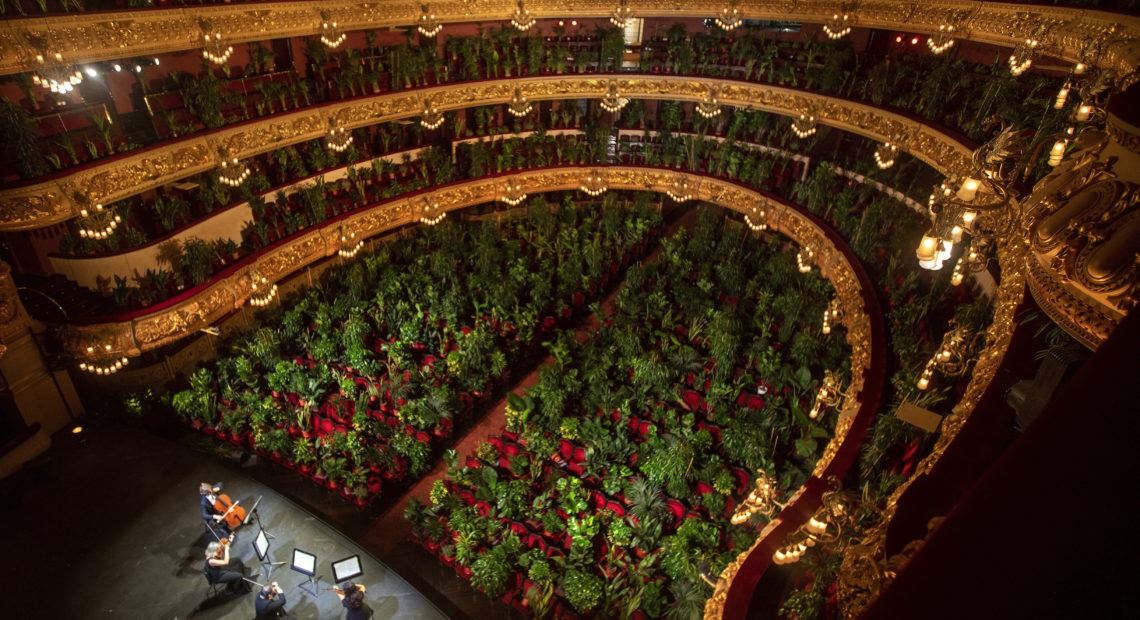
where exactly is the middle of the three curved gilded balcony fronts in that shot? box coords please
[0,74,971,230]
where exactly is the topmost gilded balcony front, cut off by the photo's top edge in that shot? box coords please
[0,0,1140,82]
